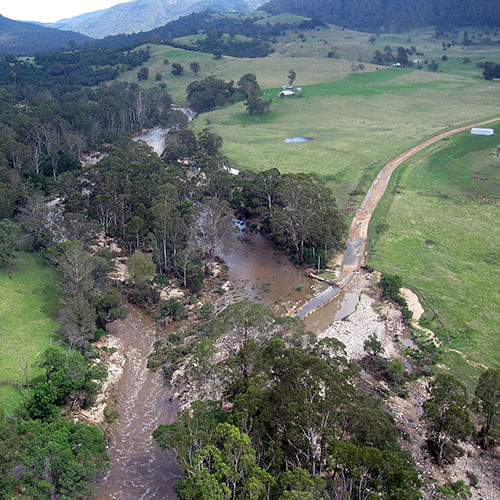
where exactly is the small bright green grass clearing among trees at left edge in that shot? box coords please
[0,254,58,411]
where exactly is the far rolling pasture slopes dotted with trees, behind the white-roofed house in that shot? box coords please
[118,21,500,104]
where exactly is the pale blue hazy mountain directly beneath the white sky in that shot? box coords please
[50,0,264,38]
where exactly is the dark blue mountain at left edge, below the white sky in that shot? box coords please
[0,15,92,56]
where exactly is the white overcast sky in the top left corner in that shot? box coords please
[0,0,129,23]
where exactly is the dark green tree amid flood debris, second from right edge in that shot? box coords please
[423,374,471,465]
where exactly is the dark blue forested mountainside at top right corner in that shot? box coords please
[261,0,500,32]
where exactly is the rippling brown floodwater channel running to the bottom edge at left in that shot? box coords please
[95,307,182,500]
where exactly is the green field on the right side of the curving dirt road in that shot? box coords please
[369,128,500,388]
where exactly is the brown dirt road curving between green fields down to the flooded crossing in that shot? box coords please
[297,117,500,316]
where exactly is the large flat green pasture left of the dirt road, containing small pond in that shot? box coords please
[194,68,500,210]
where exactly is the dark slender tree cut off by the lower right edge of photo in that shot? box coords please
[474,368,500,447]
